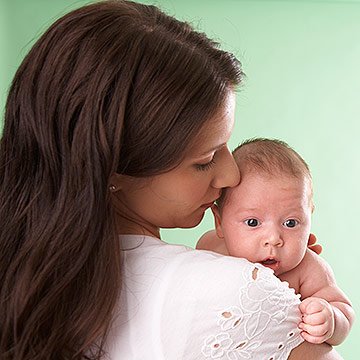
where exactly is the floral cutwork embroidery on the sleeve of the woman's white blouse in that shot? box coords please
[201,263,303,360]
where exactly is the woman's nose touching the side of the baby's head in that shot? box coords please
[212,146,240,189]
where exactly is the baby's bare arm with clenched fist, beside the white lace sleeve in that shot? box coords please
[299,250,355,345]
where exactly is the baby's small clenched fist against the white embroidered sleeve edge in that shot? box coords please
[299,297,335,344]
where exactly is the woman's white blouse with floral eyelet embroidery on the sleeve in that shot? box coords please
[104,235,303,360]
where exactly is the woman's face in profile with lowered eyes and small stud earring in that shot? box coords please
[112,91,240,236]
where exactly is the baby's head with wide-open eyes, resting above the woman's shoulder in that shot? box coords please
[213,139,314,275]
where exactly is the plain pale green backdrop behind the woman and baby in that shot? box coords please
[0,0,360,359]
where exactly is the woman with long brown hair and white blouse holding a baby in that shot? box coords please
[0,1,339,359]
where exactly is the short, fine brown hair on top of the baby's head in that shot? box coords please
[217,138,313,209]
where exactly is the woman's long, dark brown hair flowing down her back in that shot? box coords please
[0,1,242,360]
